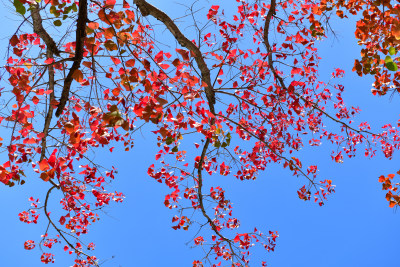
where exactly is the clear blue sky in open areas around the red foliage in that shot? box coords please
[0,0,400,267]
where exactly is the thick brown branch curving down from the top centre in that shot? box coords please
[133,0,215,114]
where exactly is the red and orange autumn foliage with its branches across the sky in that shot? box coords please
[0,0,400,266]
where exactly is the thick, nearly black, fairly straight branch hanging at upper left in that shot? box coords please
[56,0,88,117]
